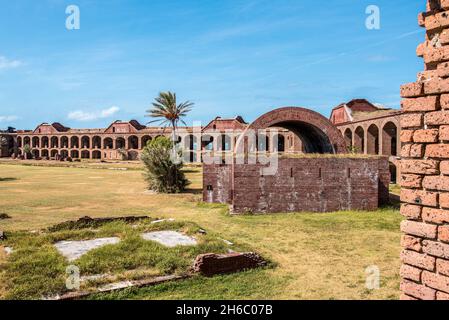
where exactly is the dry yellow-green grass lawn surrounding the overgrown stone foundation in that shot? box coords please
[0,163,402,299]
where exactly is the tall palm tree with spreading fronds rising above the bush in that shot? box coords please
[146,91,194,155]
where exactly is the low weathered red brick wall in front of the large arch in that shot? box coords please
[203,157,390,213]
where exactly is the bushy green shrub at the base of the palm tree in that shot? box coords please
[141,137,190,193]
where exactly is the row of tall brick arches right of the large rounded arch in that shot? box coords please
[344,122,399,156]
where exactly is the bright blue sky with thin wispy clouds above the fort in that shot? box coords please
[0,0,425,129]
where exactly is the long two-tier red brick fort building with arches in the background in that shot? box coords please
[0,117,302,162]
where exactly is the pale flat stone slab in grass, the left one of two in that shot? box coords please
[55,237,120,261]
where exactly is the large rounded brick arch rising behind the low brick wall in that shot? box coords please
[248,107,347,153]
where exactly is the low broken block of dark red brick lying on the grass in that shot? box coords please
[193,252,267,276]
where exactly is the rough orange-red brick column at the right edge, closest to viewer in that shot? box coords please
[401,0,449,300]
